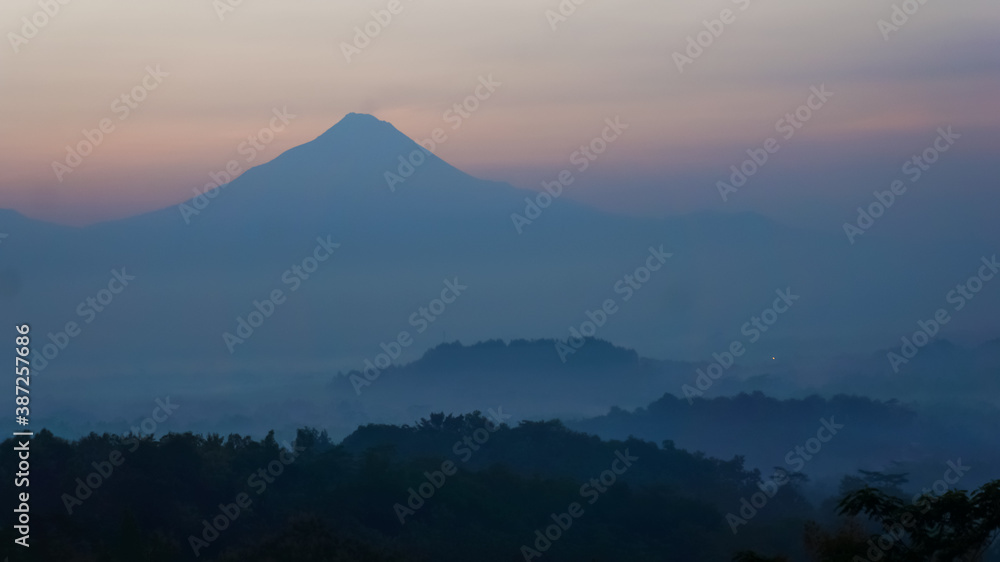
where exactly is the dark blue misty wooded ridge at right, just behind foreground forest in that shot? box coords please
[567,392,1000,486]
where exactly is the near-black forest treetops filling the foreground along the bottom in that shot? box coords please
[0,412,1000,562]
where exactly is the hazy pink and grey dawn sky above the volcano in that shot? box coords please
[0,0,1000,236]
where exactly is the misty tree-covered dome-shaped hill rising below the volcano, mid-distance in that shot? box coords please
[329,339,694,426]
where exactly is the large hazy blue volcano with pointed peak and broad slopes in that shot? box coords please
[0,114,1000,424]
